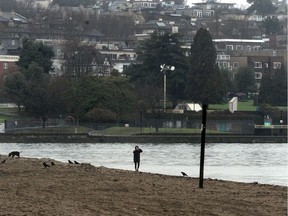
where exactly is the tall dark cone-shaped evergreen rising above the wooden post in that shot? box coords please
[185,28,226,104]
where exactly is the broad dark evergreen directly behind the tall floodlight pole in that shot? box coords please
[124,33,187,104]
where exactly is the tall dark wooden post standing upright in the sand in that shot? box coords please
[199,104,208,188]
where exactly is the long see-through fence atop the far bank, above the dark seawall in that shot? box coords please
[5,118,254,136]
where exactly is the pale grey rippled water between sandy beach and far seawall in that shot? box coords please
[0,143,288,186]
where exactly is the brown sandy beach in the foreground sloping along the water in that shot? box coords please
[0,155,287,216]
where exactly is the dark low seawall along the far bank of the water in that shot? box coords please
[0,133,287,143]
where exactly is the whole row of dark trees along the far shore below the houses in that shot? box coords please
[4,28,287,127]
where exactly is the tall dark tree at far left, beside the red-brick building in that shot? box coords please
[5,39,54,127]
